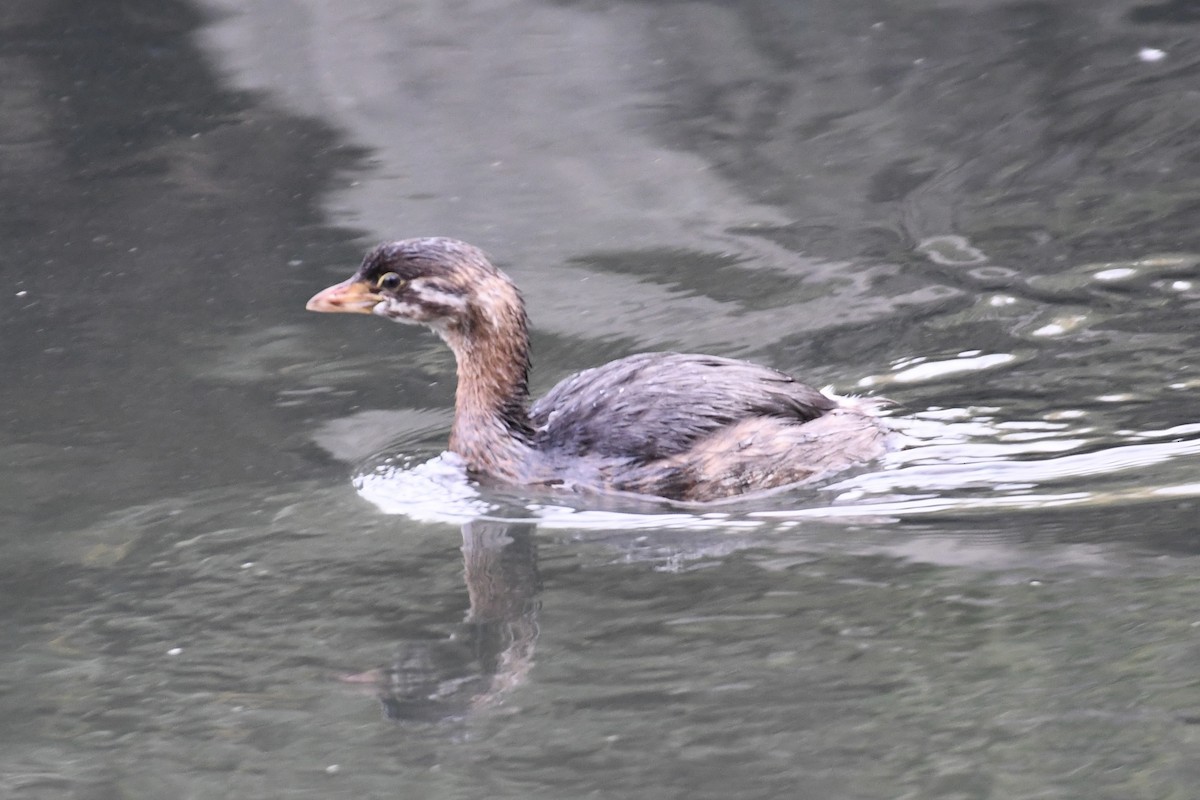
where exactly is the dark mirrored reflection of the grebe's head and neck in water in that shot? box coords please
[342,519,541,721]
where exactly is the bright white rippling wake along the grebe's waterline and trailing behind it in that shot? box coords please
[354,402,1200,530]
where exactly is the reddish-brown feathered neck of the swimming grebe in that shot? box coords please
[444,308,533,476]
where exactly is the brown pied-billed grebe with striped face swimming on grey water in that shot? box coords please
[307,239,887,501]
